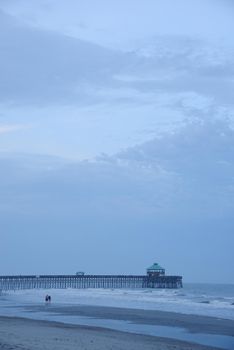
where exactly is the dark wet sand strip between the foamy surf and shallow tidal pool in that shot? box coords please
[24,304,234,337]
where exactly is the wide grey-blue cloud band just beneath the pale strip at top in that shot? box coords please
[0,7,234,110]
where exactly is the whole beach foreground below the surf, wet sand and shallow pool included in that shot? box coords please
[0,303,234,350]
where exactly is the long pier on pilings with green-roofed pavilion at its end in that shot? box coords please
[0,263,182,291]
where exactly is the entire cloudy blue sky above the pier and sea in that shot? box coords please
[0,0,234,283]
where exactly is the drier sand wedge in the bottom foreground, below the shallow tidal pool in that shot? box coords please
[0,317,223,350]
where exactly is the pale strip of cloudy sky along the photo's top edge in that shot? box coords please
[2,0,233,49]
